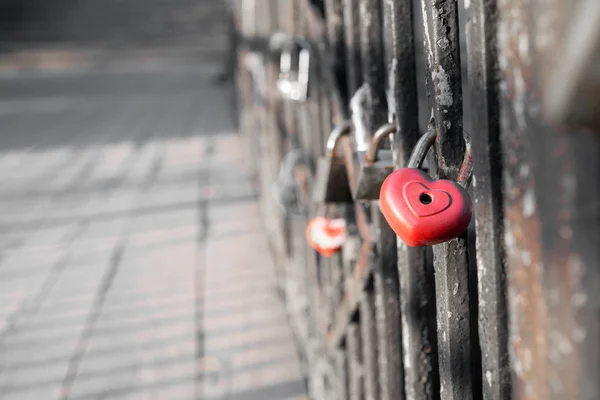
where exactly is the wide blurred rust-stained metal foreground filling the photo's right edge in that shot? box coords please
[498,1,600,399]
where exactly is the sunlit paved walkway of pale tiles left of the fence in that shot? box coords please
[0,62,306,400]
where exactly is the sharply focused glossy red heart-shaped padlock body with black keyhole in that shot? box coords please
[379,168,471,246]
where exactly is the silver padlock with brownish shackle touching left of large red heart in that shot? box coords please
[354,124,396,200]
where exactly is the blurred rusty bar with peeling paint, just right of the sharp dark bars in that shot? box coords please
[497,0,548,400]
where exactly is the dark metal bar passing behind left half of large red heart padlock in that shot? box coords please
[384,0,439,399]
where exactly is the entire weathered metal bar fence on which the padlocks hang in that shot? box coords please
[234,0,600,400]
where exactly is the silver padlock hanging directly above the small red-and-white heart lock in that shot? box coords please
[312,121,353,203]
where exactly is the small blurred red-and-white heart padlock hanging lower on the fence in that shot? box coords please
[306,217,346,257]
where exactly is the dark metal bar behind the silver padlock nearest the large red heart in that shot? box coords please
[360,0,404,399]
